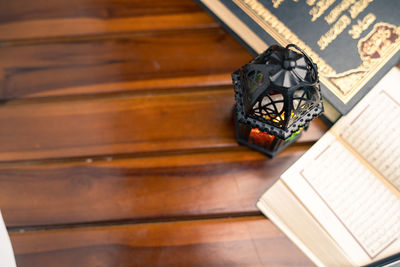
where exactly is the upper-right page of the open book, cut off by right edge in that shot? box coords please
[331,68,400,193]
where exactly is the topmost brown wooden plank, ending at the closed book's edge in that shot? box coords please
[0,0,218,42]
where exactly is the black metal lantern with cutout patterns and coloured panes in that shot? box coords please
[232,44,324,157]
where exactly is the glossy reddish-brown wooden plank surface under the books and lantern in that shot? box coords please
[0,0,327,267]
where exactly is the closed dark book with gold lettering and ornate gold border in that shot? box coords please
[197,0,400,114]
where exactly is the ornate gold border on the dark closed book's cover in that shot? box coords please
[233,0,400,104]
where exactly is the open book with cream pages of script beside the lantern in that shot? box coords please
[257,68,400,266]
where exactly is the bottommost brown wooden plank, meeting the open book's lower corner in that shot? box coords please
[10,216,313,267]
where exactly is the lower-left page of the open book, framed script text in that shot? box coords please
[282,133,400,265]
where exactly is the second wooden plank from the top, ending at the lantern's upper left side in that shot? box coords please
[0,28,251,99]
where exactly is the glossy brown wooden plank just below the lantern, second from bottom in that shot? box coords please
[0,145,309,227]
